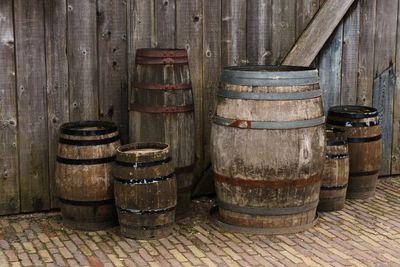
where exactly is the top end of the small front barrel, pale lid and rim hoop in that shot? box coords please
[117,142,169,162]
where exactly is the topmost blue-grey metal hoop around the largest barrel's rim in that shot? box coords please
[221,69,319,86]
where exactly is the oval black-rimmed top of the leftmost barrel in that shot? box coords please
[60,121,118,136]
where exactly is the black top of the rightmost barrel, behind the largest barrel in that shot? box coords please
[328,105,378,119]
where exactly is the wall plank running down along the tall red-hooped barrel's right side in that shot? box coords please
[176,0,203,179]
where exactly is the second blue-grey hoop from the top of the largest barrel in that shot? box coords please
[218,90,322,100]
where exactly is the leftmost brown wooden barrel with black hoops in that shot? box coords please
[55,121,120,231]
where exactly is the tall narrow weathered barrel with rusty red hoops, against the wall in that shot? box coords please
[130,49,195,217]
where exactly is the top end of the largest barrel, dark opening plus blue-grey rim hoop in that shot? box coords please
[222,65,319,86]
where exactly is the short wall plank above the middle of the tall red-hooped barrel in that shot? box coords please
[155,0,176,48]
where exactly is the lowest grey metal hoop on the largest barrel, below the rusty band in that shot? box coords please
[218,200,318,216]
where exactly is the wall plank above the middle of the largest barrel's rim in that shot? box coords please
[246,0,272,64]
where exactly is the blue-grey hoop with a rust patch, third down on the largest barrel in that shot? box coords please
[213,116,325,129]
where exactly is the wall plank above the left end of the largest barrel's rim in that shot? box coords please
[221,0,247,67]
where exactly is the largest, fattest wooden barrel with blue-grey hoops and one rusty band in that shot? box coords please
[211,66,325,233]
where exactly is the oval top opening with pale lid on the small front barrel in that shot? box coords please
[117,142,169,157]
